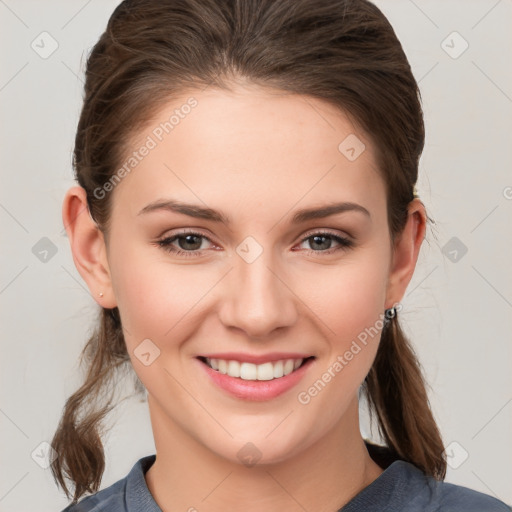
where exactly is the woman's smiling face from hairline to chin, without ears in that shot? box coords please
[100,87,412,463]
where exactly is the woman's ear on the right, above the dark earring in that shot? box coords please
[386,199,427,308]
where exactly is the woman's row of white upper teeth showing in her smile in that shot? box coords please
[206,357,304,380]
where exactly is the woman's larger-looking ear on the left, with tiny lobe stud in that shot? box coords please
[62,186,117,309]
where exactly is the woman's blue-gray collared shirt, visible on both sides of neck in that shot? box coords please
[62,445,512,512]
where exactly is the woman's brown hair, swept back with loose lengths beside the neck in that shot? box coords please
[51,0,446,501]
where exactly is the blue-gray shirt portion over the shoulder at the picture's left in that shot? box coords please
[62,455,157,512]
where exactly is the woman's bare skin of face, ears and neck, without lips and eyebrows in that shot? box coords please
[63,85,426,512]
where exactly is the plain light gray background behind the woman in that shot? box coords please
[0,0,512,512]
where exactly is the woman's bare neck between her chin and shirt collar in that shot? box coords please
[145,397,383,512]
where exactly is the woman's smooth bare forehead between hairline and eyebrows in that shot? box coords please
[110,86,385,221]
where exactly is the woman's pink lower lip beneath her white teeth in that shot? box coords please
[197,359,314,401]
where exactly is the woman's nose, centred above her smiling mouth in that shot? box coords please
[219,251,298,339]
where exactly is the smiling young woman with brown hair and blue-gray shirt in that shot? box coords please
[52,0,510,512]
